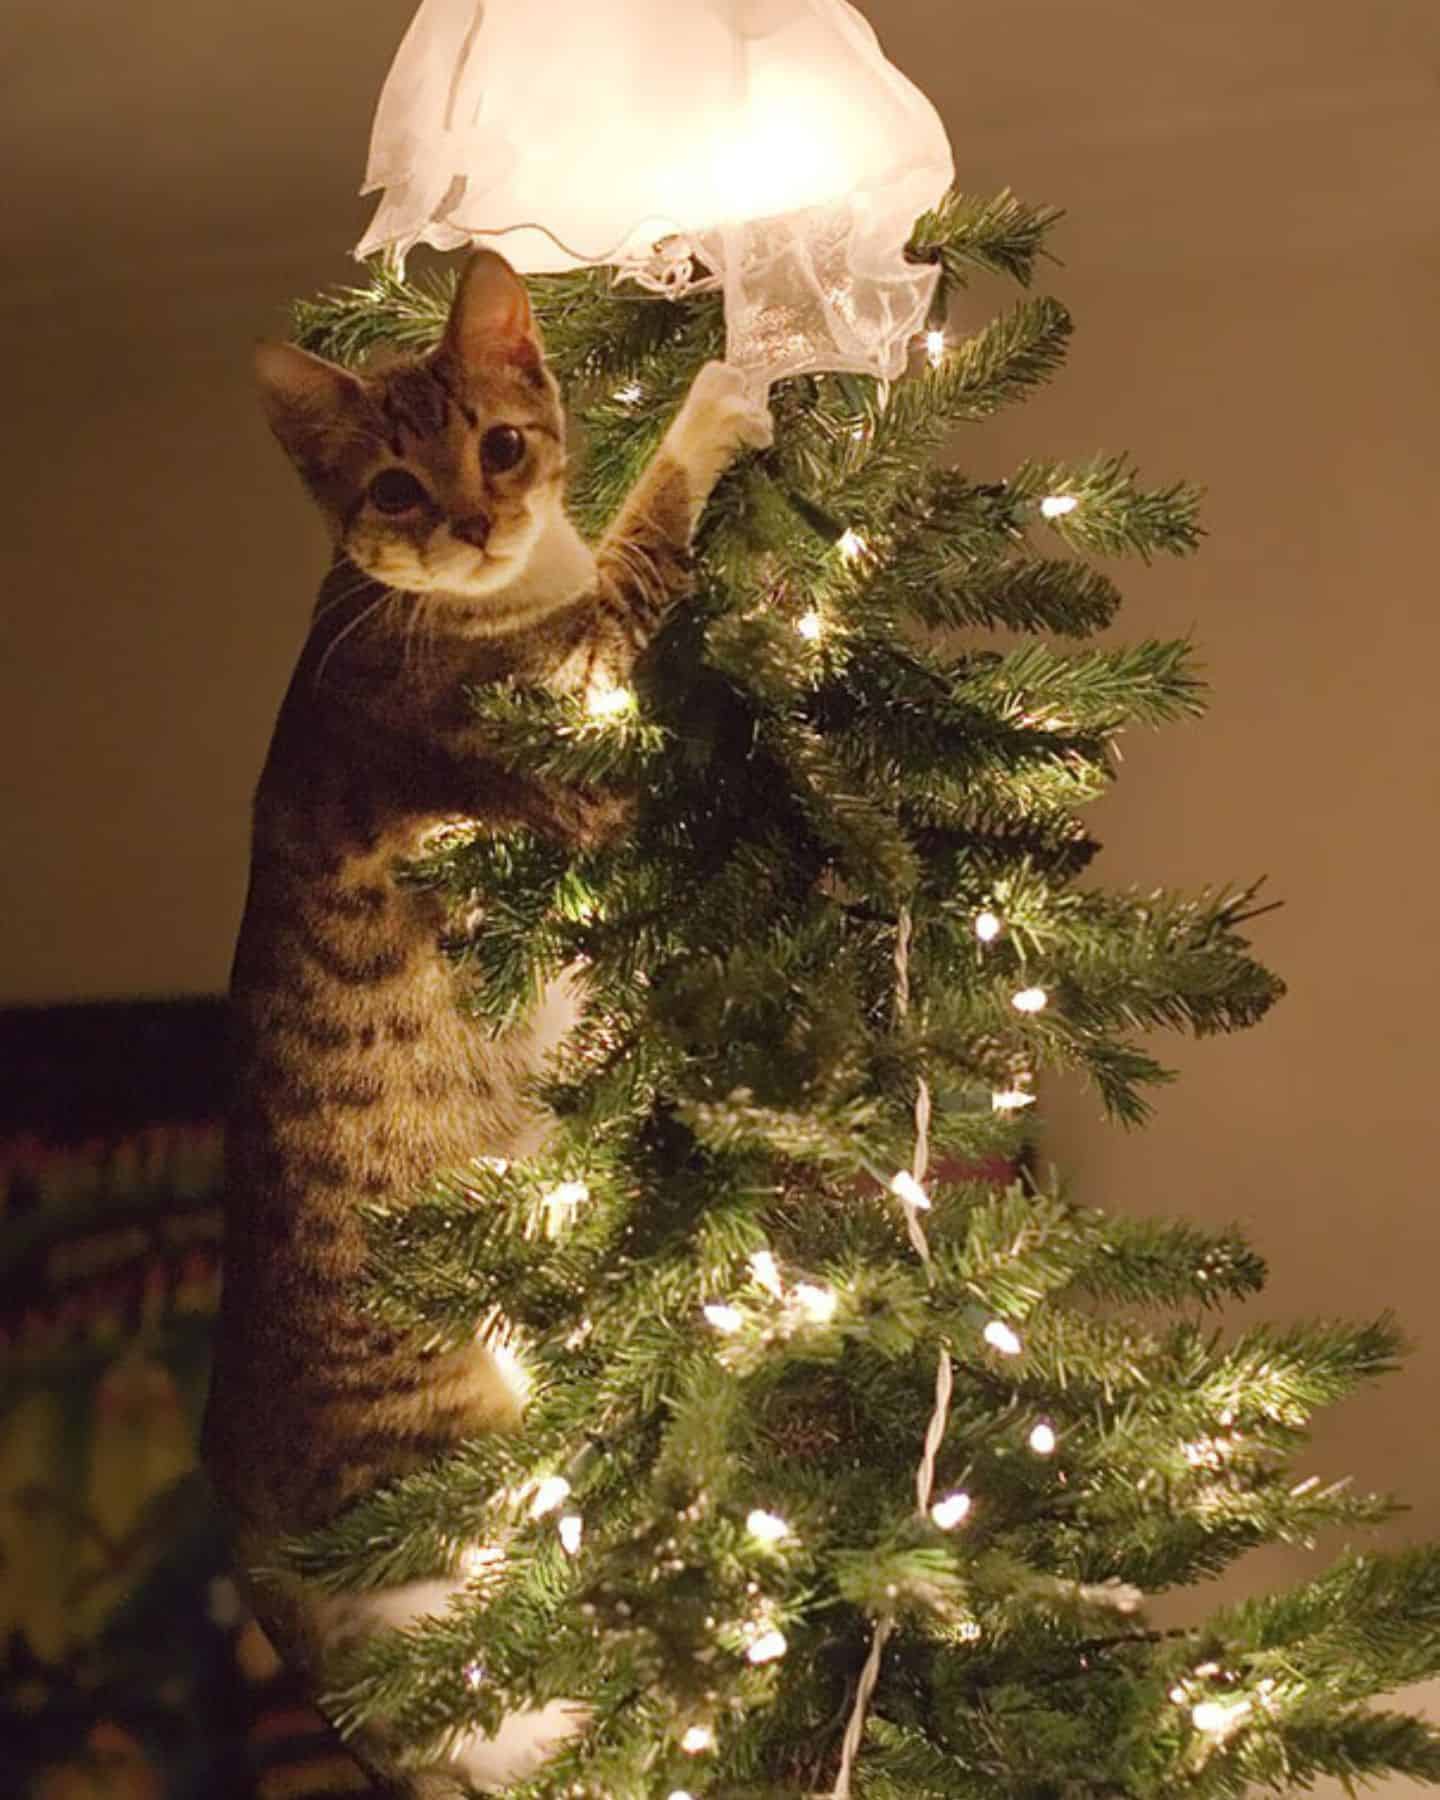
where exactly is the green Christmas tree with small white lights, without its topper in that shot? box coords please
[270,193,1440,1800]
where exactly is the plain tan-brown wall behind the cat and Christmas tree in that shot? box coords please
[0,0,1440,1785]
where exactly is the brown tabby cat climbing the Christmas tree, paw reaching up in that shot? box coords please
[203,250,770,1800]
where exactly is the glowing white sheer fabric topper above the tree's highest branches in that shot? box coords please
[356,0,954,387]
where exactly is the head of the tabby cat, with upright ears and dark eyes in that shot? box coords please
[256,250,565,594]
